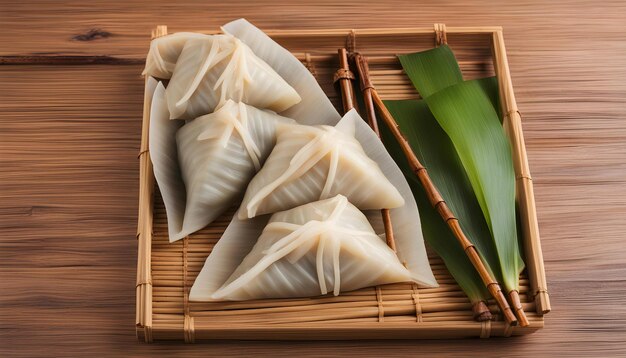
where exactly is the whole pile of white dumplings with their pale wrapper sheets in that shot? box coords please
[145,20,437,301]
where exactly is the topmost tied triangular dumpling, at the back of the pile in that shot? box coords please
[167,35,300,119]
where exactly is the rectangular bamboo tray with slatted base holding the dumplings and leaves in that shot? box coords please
[136,24,550,342]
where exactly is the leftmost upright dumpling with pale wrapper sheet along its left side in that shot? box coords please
[150,84,293,242]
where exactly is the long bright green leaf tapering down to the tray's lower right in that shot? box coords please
[425,79,523,290]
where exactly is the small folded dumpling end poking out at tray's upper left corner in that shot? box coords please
[143,32,208,79]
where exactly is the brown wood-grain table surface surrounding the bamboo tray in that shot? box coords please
[0,0,626,357]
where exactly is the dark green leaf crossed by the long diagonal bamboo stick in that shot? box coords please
[381,100,490,302]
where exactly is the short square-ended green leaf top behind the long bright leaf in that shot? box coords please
[398,45,463,98]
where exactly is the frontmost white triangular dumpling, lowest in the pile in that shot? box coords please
[189,195,411,301]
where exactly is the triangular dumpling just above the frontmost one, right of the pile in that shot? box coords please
[239,112,404,219]
